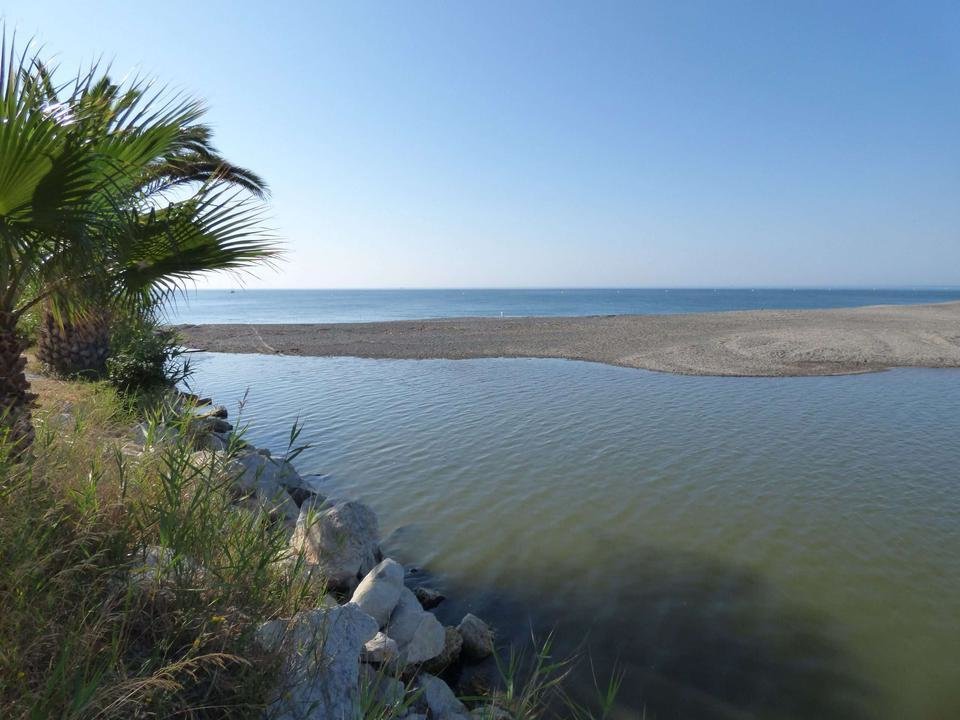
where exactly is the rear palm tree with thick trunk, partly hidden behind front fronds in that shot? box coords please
[31,73,267,376]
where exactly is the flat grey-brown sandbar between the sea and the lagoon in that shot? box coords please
[177,302,960,376]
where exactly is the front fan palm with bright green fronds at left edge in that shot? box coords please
[0,29,277,454]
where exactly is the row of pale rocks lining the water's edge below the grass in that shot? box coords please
[137,394,502,720]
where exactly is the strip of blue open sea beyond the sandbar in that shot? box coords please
[163,288,960,324]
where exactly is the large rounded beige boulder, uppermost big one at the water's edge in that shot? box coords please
[290,500,380,599]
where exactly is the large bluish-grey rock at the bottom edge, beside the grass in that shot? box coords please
[257,603,377,720]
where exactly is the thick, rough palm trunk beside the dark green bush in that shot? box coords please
[37,310,110,378]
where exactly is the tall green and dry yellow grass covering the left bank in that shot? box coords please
[0,384,323,718]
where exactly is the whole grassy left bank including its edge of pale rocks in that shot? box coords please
[0,368,536,720]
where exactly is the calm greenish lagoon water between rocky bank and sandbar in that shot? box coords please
[188,354,960,720]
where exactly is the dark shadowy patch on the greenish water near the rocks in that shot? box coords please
[414,548,877,720]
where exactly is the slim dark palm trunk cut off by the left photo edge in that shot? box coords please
[0,312,36,458]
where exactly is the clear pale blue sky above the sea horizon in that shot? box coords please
[2,0,960,288]
